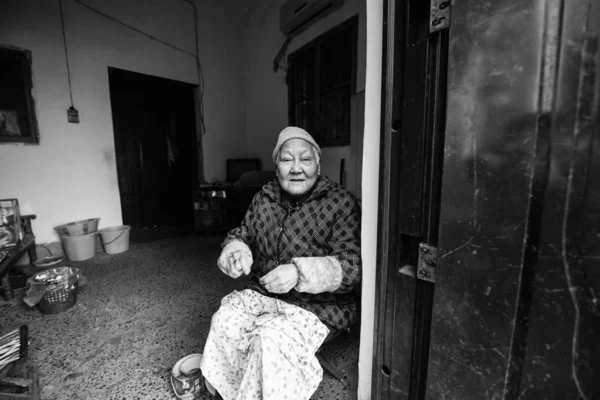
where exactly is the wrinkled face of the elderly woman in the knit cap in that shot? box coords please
[277,139,320,196]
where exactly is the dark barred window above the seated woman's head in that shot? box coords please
[287,16,358,147]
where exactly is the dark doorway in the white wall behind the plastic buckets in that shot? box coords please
[109,68,198,227]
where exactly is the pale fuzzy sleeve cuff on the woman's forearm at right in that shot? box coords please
[292,257,342,294]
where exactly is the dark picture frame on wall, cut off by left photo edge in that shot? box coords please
[0,46,39,144]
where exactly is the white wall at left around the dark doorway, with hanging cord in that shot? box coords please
[0,0,246,243]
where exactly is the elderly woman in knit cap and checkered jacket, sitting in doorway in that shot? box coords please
[201,127,361,400]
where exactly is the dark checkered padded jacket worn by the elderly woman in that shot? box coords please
[223,177,362,333]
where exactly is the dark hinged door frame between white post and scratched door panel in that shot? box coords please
[372,0,448,399]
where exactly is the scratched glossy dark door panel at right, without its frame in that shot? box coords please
[426,0,600,400]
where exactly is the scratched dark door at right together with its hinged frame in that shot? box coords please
[372,0,600,400]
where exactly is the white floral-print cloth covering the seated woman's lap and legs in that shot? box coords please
[201,291,329,400]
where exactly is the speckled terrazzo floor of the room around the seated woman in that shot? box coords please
[0,231,359,400]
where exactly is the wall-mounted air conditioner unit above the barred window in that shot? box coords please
[279,0,344,36]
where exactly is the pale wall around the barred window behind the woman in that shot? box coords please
[244,0,366,188]
